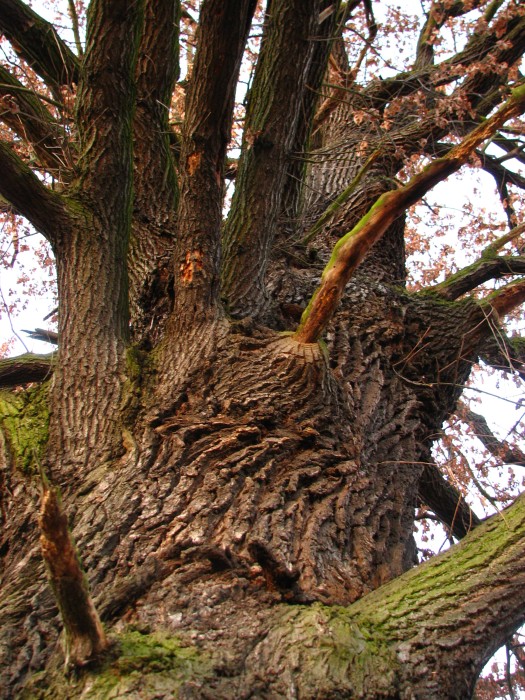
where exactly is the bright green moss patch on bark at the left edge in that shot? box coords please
[0,384,49,473]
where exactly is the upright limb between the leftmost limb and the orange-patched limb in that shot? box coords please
[128,0,180,340]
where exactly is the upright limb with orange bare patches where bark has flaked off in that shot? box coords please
[175,0,256,319]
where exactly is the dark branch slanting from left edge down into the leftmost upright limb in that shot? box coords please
[0,141,70,243]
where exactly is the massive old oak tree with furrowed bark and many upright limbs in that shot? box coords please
[0,0,525,699]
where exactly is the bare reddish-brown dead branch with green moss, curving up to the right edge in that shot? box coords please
[294,85,525,343]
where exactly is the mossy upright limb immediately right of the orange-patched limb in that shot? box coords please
[223,0,328,316]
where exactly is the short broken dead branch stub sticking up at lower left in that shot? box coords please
[40,483,108,667]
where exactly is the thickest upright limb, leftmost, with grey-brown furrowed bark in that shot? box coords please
[44,0,144,482]
